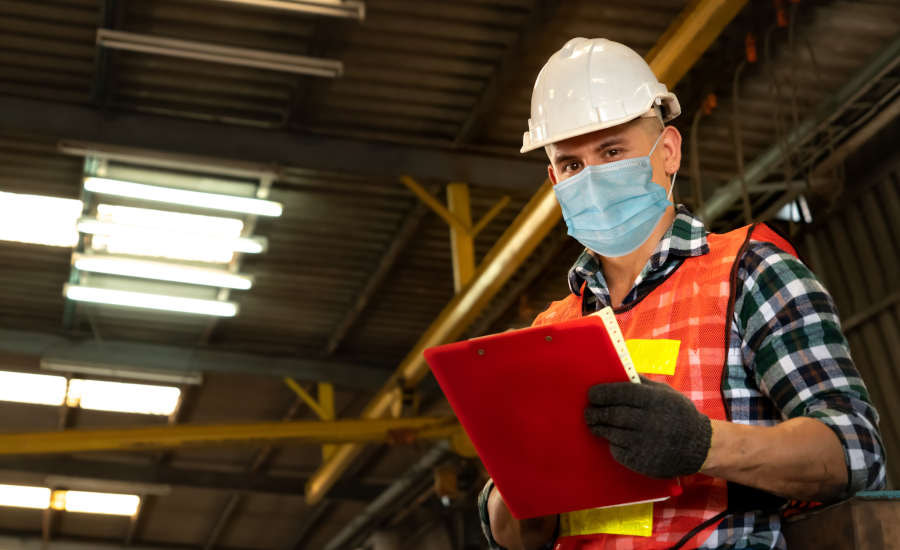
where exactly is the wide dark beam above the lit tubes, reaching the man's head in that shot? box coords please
[0,96,544,192]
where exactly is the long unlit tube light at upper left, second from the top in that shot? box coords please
[97,29,344,78]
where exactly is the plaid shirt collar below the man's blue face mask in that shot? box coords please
[569,205,709,296]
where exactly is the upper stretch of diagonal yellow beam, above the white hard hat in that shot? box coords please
[646,0,747,90]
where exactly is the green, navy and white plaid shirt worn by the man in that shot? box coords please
[477,207,885,550]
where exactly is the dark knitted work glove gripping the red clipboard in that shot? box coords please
[584,376,712,478]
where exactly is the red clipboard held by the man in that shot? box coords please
[424,315,681,519]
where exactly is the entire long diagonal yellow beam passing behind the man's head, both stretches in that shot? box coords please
[306,0,743,504]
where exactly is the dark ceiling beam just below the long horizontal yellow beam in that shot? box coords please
[0,456,385,500]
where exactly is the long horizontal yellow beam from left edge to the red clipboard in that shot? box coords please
[0,417,460,455]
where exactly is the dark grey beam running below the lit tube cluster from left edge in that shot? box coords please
[0,329,388,390]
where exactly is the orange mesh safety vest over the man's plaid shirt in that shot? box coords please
[533,225,796,550]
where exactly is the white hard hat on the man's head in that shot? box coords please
[521,38,681,153]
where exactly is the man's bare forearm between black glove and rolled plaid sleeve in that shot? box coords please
[700,418,847,500]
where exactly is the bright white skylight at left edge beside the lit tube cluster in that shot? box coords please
[0,192,84,247]
